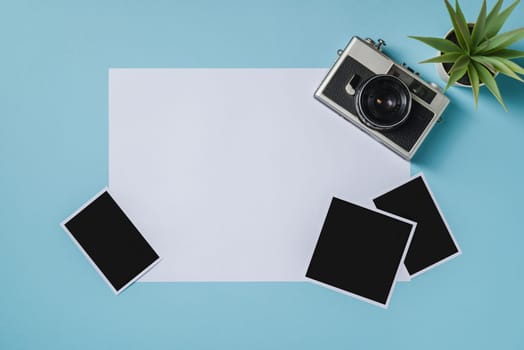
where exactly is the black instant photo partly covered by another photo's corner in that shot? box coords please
[373,174,461,278]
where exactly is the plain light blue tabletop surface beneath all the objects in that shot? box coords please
[0,0,524,349]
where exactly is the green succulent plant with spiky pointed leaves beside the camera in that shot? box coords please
[410,0,524,110]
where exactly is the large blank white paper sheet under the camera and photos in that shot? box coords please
[109,69,410,281]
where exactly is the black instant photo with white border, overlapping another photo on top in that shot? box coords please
[306,197,417,308]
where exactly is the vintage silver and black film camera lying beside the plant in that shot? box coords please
[315,36,449,160]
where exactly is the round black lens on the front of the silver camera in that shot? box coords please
[356,74,411,130]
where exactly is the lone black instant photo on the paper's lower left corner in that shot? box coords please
[61,188,160,295]
